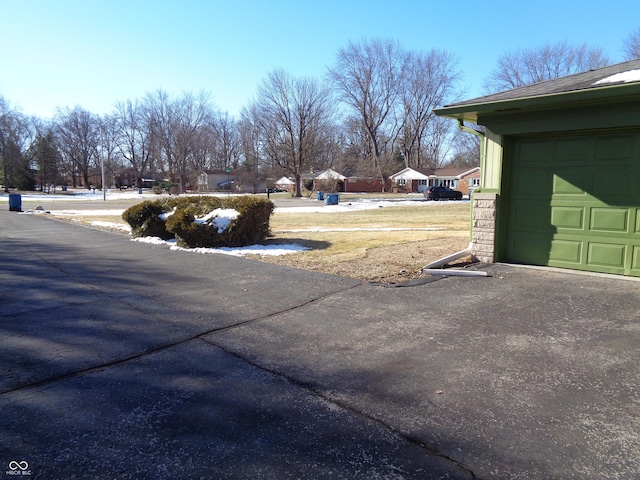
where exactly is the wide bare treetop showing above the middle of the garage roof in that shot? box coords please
[484,41,610,93]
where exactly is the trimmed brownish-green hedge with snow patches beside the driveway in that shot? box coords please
[122,196,274,248]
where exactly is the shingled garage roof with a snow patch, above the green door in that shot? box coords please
[434,58,640,123]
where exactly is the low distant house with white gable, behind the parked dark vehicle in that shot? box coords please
[389,167,480,195]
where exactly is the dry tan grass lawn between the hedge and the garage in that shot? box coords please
[261,202,470,283]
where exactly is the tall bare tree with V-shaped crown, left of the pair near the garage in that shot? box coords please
[329,39,407,187]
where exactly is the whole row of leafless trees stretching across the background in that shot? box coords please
[0,28,640,195]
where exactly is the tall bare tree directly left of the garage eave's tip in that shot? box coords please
[400,50,461,168]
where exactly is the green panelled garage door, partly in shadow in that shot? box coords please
[503,131,640,276]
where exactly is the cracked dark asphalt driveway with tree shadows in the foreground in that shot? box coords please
[0,211,640,479]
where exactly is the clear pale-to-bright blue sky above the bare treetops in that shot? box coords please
[0,0,640,118]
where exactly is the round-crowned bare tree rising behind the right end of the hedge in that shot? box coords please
[254,70,332,197]
